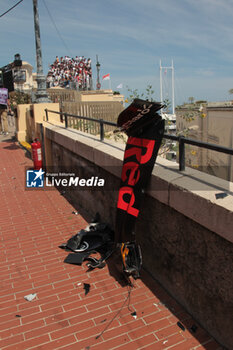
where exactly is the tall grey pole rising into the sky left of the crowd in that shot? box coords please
[33,0,51,103]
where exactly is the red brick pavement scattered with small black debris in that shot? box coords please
[0,141,222,350]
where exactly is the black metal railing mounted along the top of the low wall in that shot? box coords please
[45,108,233,171]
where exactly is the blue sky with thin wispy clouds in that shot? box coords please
[0,0,233,105]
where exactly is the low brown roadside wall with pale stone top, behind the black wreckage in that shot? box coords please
[44,123,233,349]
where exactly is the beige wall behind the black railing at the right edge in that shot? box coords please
[176,101,233,181]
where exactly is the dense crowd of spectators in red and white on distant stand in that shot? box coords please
[47,56,92,90]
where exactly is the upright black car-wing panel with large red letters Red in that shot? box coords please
[115,100,164,243]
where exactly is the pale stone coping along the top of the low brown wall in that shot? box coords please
[44,123,233,242]
